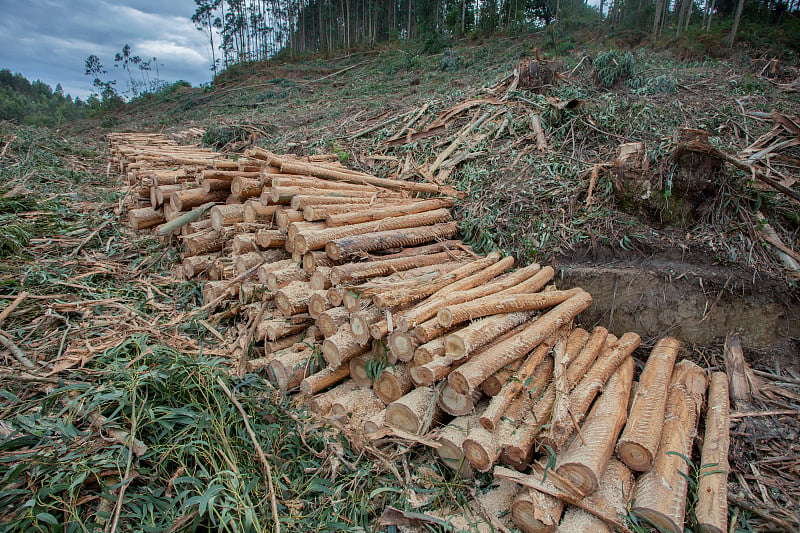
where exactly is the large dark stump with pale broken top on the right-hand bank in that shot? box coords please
[612,128,723,227]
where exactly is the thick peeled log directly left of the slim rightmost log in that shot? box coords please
[631,359,707,533]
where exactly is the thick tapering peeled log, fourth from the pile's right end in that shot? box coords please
[556,357,633,494]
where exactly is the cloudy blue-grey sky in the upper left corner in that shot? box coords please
[0,0,216,99]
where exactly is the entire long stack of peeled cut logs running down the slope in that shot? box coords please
[110,134,729,531]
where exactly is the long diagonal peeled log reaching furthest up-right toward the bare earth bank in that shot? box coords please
[447,291,592,393]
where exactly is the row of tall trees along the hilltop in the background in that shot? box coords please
[192,0,800,69]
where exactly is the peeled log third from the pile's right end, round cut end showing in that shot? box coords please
[617,337,681,472]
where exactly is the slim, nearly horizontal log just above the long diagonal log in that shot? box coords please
[436,288,583,327]
